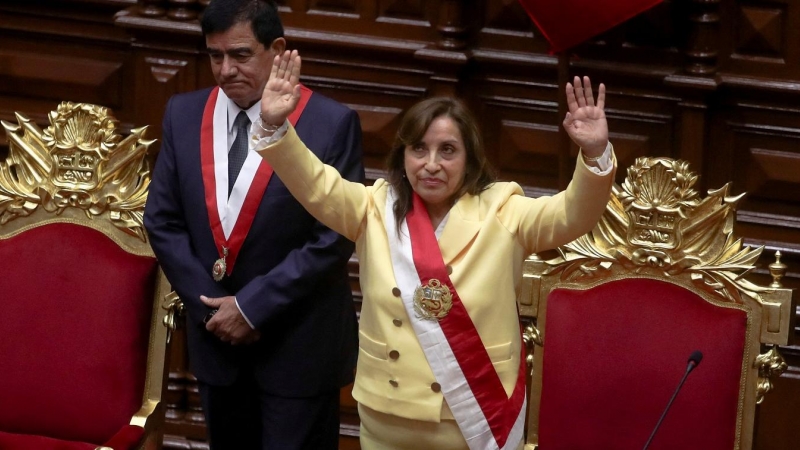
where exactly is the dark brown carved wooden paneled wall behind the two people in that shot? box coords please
[0,0,800,450]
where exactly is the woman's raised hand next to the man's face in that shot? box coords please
[261,50,301,126]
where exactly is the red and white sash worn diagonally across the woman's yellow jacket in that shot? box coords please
[385,188,526,450]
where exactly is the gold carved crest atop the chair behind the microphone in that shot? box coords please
[546,158,770,303]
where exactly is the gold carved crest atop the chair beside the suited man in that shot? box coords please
[0,102,155,242]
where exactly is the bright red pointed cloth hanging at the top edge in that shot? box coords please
[519,0,661,52]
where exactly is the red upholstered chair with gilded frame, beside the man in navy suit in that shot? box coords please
[0,103,180,450]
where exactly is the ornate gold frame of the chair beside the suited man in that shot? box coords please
[0,102,182,449]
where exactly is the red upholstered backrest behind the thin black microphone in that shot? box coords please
[539,279,748,450]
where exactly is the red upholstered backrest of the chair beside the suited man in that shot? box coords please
[0,224,156,445]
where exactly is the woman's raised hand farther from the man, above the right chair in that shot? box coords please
[564,77,608,158]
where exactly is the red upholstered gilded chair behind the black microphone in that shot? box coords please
[519,158,794,450]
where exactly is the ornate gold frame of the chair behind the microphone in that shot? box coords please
[519,158,795,450]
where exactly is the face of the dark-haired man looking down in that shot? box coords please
[206,22,286,109]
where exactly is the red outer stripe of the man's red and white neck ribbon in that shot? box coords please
[200,85,313,275]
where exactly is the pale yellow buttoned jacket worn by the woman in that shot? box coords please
[258,127,616,422]
